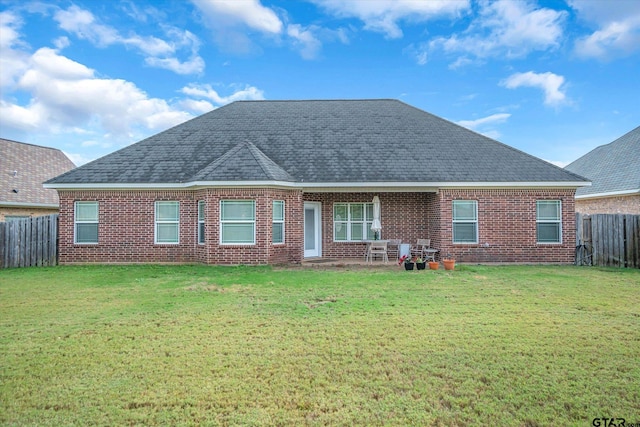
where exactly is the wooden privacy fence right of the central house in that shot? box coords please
[576,213,640,268]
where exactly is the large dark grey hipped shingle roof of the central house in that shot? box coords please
[48,100,588,188]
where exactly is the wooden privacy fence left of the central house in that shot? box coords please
[0,214,58,268]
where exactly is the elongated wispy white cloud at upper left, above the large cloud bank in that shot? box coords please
[54,6,205,74]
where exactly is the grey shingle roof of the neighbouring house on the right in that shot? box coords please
[565,126,640,198]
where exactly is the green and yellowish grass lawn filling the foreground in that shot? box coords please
[0,265,640,426]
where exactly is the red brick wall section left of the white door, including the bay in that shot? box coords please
[59,189,303,264]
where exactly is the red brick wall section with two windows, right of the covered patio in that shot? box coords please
[439,189,575,263]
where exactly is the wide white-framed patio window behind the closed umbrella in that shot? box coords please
[333,203,374,242]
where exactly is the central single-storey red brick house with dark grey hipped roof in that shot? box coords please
[46,100,589,264]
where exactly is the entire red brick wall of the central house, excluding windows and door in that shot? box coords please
[59,188,575,264]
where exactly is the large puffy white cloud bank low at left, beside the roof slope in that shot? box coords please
[0,48,191,135]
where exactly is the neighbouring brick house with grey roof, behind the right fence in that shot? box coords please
[565,126,640,215]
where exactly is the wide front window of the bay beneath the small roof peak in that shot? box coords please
[220,200,256,245]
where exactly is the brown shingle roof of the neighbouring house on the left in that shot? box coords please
[0,138,75,208]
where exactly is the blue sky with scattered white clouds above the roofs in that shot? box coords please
[0,0,640,166]
